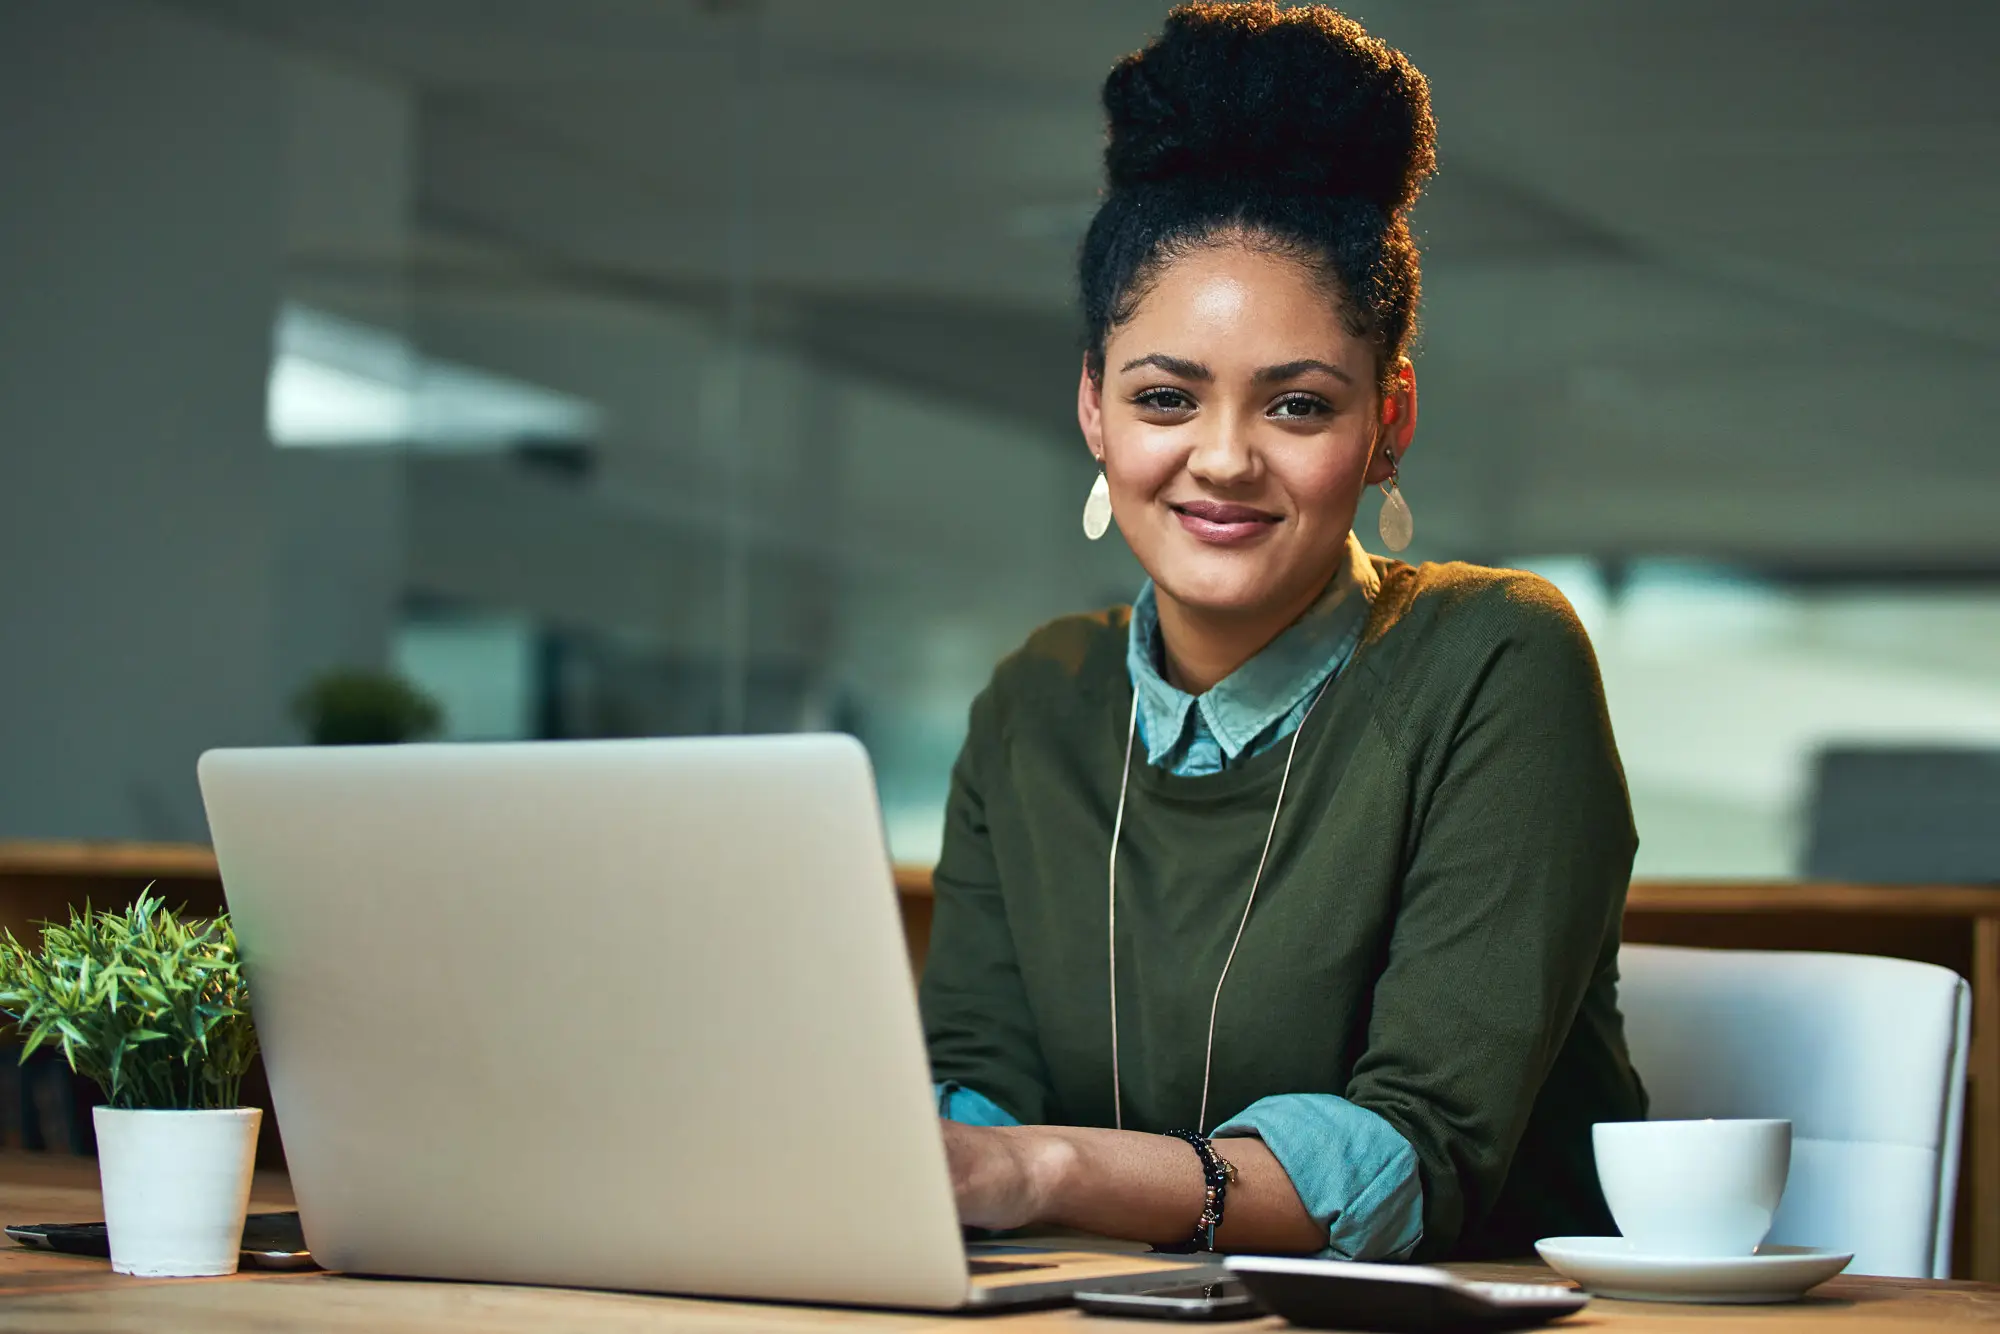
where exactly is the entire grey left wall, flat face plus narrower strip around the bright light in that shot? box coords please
[0,0,412,838]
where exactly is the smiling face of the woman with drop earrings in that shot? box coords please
[1078,242,1416,620]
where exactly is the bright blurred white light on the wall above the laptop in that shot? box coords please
[264,304,602,452]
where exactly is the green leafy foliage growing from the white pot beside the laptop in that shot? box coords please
[0,888,258,1110]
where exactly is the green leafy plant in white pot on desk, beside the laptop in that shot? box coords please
[0,886,264,1276]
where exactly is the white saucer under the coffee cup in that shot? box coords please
[1534,1236,1854,1302]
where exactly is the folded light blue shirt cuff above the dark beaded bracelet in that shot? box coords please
[1216,1094,1424,1260]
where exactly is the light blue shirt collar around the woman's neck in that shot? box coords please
[1126,534,1380,766]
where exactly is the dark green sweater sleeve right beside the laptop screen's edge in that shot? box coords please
[918,690,1050,1124]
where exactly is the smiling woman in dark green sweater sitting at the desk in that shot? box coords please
[922,4,1644,1260]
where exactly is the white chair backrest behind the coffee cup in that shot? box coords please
[1618,944,1972,1278]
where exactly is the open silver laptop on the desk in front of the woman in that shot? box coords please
[200,736,1188,1310]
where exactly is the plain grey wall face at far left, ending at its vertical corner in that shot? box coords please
[0,0,284,838]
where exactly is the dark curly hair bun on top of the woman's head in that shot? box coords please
[1104,2,1438,216]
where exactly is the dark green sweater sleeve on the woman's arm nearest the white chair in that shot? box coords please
[1346,578,1638,1258]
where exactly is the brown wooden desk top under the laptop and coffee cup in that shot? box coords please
[0,1154,2000,1334]
